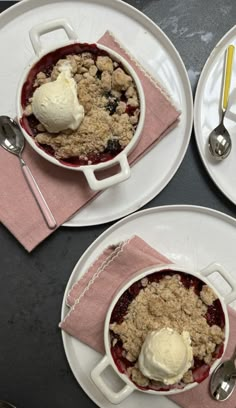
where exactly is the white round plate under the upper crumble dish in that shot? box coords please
[0,0,193,227]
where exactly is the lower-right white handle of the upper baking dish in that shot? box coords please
[83,154,130,191]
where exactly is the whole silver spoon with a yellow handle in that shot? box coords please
[208,45,234,160]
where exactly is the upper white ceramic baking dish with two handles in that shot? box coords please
[17,19,145,191]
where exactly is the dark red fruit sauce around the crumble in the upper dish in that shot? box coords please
[20,43,135,167]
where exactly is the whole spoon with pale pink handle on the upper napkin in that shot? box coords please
[0,116,57,230]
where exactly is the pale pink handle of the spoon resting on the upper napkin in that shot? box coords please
[20,158,57,229]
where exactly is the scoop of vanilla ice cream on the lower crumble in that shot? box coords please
[138,328,193,385]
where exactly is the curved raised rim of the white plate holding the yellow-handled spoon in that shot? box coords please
[193,25,236,204]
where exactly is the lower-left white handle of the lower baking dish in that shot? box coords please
[91,356,134,404]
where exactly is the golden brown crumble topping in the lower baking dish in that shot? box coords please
[110,274,224,386]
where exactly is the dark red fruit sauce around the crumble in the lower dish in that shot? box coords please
[110,270,225,391]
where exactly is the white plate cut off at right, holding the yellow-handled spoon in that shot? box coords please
[194,26,236,204]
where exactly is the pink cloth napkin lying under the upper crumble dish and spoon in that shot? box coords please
[0,32,179,251]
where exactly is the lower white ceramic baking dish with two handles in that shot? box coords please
[91,263,236,404]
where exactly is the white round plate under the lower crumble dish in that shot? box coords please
[61,206,236,408]
